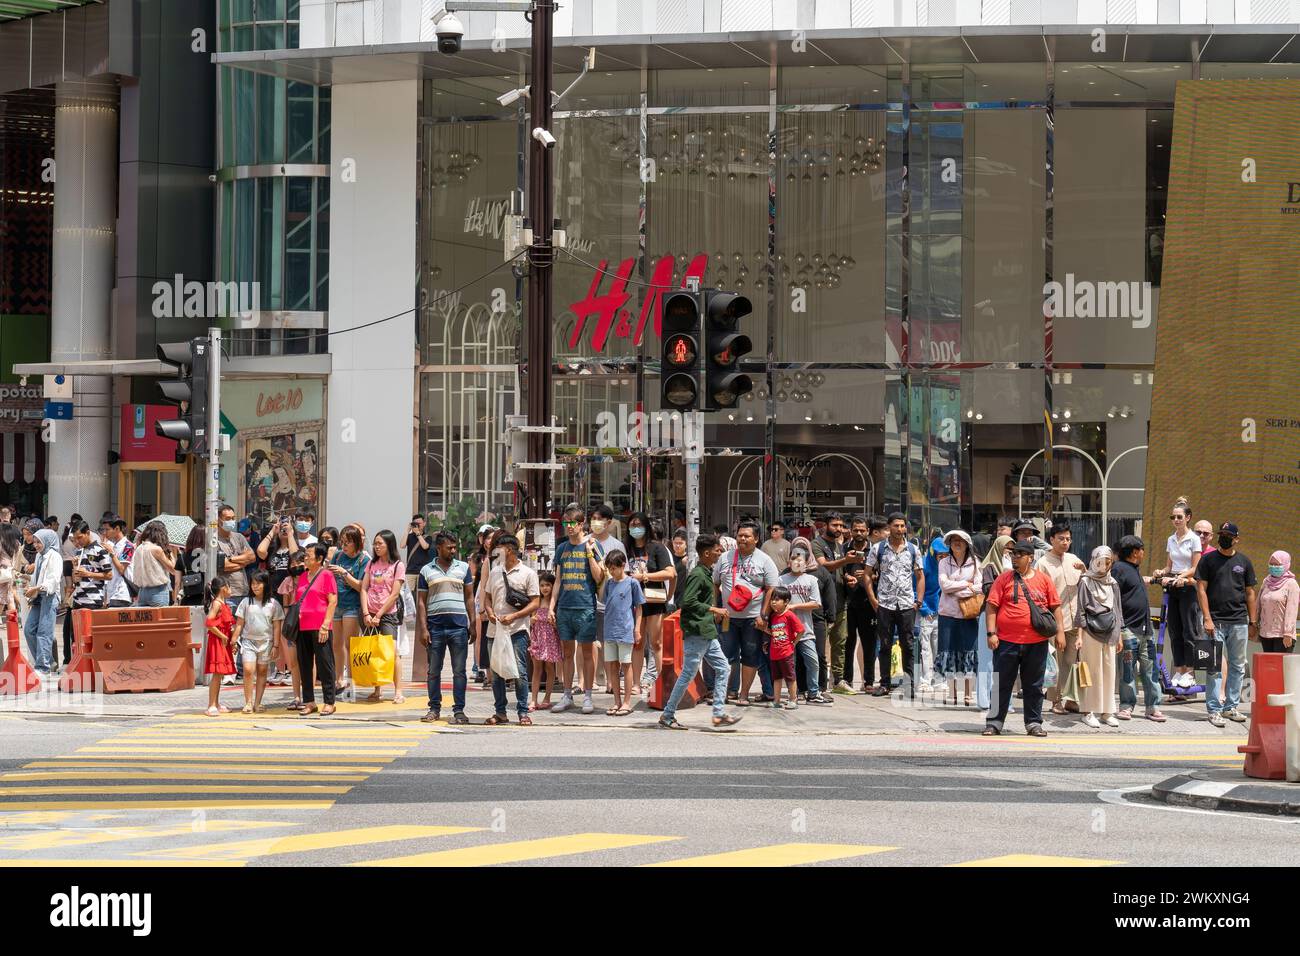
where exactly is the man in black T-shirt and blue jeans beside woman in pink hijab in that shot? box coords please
[1196,522,1260,727]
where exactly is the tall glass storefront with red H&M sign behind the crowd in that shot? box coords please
[419,62,1237,546]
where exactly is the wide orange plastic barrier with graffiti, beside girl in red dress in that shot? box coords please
[85,607,199,693]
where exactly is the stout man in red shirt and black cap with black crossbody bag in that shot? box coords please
[984,541,1065,737]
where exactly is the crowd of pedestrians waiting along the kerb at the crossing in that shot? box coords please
[0,498,1300,736]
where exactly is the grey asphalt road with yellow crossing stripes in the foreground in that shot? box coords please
[0,695,1284,866]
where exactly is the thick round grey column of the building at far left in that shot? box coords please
[47,82,117,524]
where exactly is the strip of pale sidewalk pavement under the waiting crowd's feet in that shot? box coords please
[0,665,1248,741]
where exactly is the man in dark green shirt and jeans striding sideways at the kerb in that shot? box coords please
[659,535,740,730]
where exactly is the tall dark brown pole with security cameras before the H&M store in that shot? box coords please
[527,0,555,518]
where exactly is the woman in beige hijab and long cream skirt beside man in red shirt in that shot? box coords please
[1075,545,1123,730]
